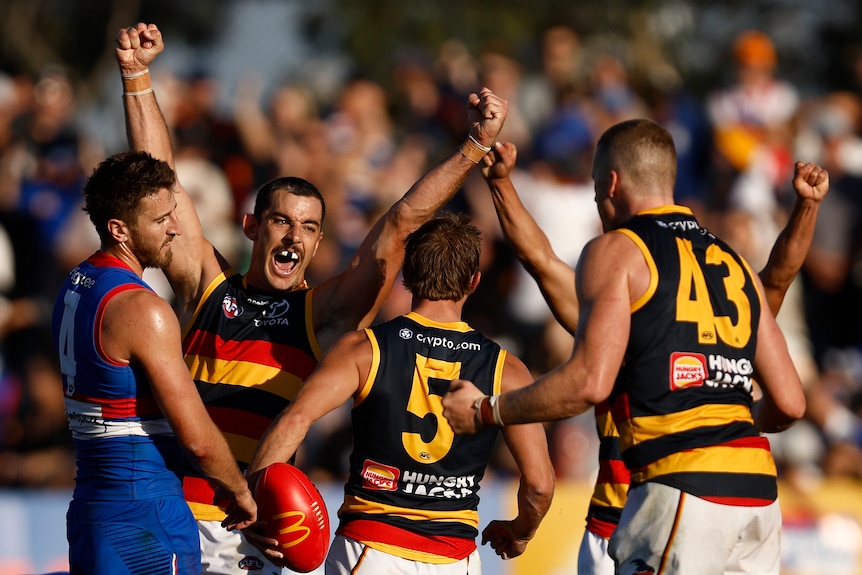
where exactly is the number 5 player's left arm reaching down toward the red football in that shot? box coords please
[248,331,372,480]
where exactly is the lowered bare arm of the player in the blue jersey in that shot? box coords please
[102,290,257,528]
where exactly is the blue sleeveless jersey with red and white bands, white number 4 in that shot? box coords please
[52,252,183,501]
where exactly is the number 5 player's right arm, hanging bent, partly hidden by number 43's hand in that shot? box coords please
[482,354,554,559]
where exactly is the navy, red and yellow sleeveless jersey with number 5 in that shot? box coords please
[339,312,506,559]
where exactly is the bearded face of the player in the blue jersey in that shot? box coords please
[114,188,183,270]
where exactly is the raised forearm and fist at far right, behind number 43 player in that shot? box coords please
[760,162,829,315]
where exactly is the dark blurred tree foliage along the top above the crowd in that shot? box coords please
[0,0,862,104]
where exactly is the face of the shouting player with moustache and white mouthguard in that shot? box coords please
[242,191,323,291]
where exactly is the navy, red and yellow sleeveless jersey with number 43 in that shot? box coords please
[611,206,777,505]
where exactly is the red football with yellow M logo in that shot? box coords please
[254,463,329,573]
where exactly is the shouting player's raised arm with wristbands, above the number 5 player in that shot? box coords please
[312,88,508,350]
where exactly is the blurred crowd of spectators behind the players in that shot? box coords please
[0,26,862,496]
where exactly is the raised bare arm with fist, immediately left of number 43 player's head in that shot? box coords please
[482,142,578,335]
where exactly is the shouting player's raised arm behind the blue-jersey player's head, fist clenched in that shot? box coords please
[116,23,227,321]
